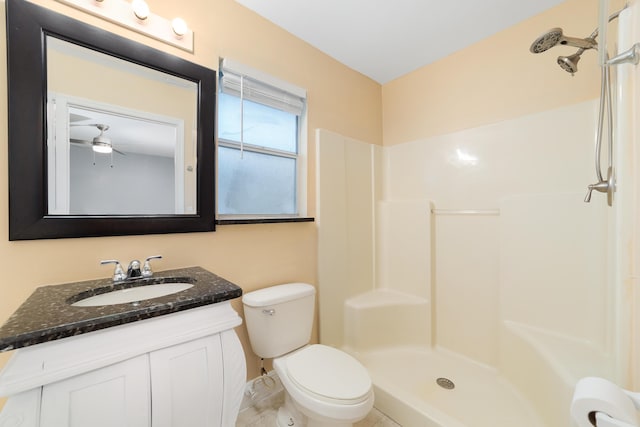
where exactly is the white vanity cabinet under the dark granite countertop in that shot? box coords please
[0,302,246,427]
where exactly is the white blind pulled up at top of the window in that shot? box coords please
[220,58,306,115]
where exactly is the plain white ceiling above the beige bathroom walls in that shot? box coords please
[236,0,564,84]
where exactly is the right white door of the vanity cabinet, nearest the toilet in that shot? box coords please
[149,335,223,427]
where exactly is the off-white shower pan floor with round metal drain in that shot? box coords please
[355,347,545,427]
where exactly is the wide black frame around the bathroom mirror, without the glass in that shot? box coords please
[6,0,216,240]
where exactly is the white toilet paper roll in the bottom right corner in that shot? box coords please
[571,377,638,427]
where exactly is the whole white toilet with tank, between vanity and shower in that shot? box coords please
[242,283,373,427]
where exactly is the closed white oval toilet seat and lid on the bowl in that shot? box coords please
[286,344,371,405]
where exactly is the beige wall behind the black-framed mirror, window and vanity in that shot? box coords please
[0,0,382,408]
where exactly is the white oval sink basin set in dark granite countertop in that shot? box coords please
[71,282,193,307]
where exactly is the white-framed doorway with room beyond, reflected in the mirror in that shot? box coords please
[47,92,189,215]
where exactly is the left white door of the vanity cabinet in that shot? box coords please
[40,355,151,427]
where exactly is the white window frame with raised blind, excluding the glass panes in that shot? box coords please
[216,58,308,220]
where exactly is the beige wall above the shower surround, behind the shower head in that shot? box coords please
[382,0,616,146]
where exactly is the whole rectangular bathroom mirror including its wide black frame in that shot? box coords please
[6,0,216,240]
